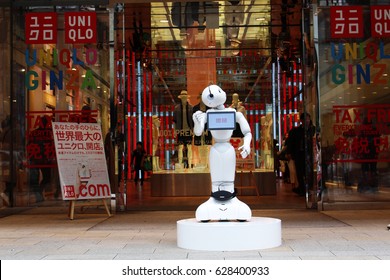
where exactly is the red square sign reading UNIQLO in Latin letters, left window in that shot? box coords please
[64,12,96,44]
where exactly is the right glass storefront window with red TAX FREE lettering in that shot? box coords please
[316,5,390,205]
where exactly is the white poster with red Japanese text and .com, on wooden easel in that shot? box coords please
[52,122,111,200]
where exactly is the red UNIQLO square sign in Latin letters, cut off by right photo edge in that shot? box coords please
[371,5,390,38]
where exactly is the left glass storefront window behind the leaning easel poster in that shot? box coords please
[0,1,110,206]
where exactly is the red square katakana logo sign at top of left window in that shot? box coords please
[25,13,57,44]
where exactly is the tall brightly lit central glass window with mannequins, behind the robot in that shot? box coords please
[148,2,273,175]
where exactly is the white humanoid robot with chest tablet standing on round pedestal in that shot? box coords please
[193,85,252,222]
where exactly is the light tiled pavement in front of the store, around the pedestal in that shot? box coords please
[0,207,390,260]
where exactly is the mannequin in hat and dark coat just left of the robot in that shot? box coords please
[173,90,194,169]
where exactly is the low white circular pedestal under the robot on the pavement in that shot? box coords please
[177,217,282,251]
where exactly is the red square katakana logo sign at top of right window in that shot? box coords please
[330,6,364,38]
